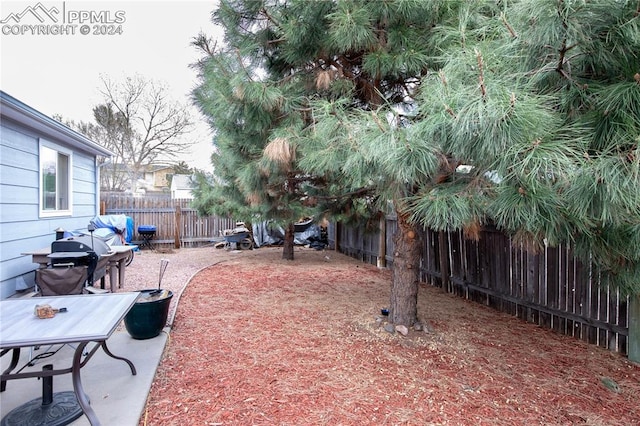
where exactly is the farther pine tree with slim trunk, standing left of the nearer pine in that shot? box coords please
[194,1,336,260]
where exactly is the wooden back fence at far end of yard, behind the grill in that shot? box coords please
[100,193,235,248]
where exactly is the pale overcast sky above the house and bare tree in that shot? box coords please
[0,0,219,170]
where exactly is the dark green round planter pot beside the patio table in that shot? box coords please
[124,290,173,340]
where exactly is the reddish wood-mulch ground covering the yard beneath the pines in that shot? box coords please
[140,248,640,426]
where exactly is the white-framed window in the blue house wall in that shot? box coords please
[40,141,71,216]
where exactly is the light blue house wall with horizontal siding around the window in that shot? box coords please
[0,92,111,299]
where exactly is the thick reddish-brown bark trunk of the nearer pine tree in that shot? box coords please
[389,212,420,327]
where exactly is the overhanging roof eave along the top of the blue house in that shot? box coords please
[0,90,113,157]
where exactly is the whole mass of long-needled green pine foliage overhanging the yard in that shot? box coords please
[194,0,640,292]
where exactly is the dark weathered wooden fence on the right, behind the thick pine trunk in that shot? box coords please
[329,217,640,354]
